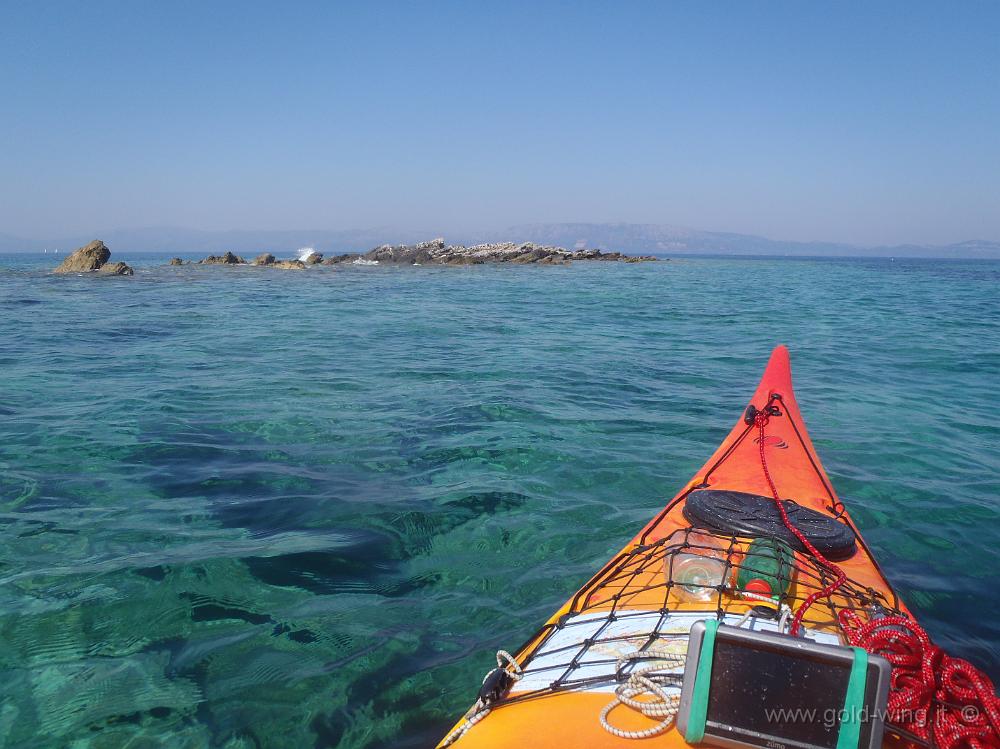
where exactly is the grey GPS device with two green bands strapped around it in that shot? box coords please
[677,619,891,749]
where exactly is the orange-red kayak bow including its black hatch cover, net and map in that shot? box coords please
[440,346,909,749]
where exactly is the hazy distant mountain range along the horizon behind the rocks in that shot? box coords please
[0,224,1000,259]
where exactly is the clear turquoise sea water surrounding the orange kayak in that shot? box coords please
[0,253,1000,749]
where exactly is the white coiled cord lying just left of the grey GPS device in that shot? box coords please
[600,648,686,739]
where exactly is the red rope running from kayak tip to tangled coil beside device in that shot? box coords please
[754,407,1000,749]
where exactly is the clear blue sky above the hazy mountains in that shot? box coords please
[0,0,1000,243]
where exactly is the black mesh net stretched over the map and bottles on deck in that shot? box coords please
[501,528,901,703]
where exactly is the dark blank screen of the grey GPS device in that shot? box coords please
[707,635,851,749]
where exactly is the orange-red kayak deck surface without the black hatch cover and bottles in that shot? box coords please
[439,346,908,749]
